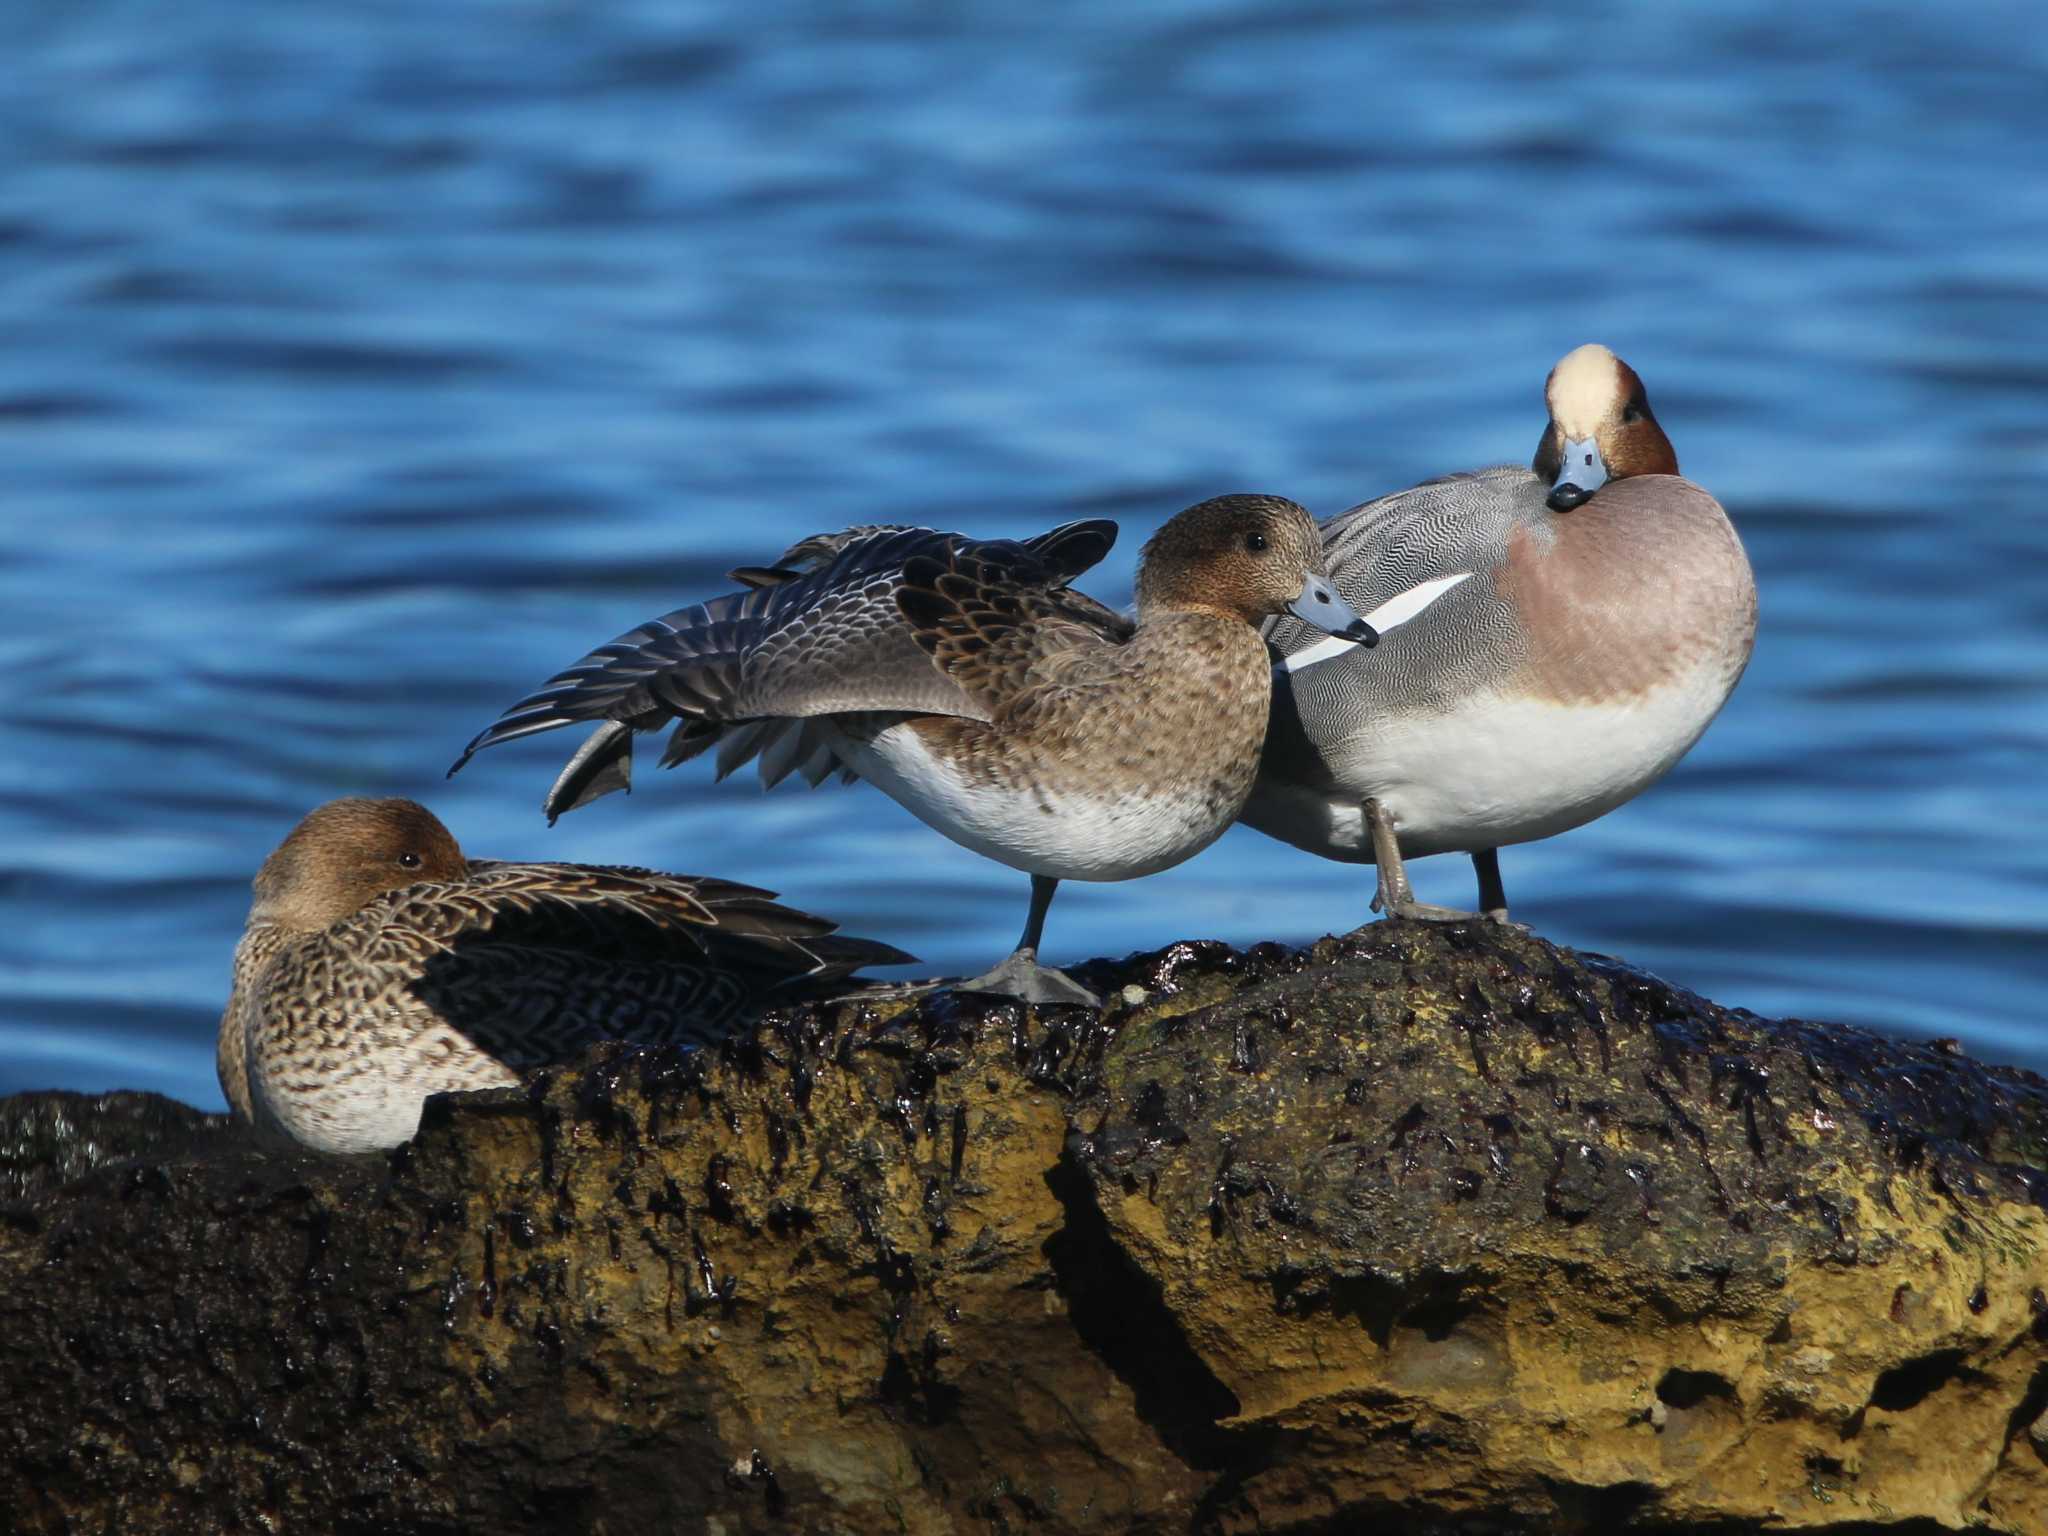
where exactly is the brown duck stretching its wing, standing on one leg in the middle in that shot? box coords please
[449,494,1441,1008]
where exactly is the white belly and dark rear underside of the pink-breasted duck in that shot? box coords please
[1243,666,1733,864]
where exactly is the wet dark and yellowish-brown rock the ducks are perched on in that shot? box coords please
[0,924,2048,1532]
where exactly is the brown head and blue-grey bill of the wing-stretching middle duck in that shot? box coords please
[1139,496,1378,645]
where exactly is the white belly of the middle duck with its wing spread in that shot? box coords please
[834,725,1237,881]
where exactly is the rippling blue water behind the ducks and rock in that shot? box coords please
[0,0,2048,1106]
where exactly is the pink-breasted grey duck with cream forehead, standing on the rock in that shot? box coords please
[1243,344,1757,922]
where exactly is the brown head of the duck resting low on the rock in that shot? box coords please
[250,799,469,934]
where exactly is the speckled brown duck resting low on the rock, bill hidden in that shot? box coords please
[215,799,913,1153]
